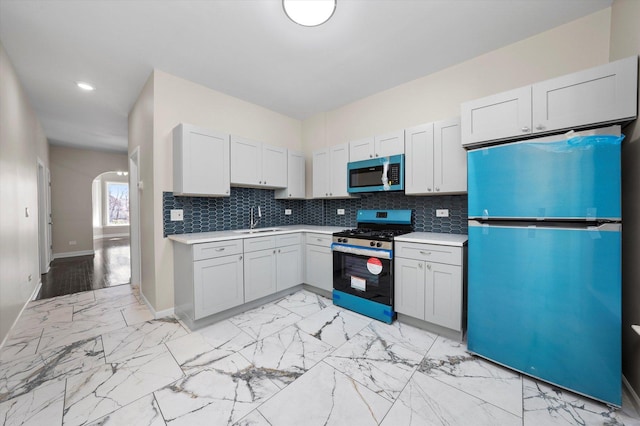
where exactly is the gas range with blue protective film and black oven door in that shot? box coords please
[331,210,412,323]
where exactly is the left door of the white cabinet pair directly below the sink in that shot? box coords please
[244,249,276,302]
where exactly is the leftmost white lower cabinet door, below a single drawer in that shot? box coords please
[193,255,244,319]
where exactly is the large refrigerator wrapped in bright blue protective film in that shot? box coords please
[467,126,623,406]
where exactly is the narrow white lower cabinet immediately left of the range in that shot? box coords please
[304,233,333,292]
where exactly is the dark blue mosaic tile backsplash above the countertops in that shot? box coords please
[162,188,467,237]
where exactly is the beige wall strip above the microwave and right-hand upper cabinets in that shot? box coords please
[302,9,611,194]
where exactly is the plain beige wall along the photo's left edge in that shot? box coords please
[0,42,49,342]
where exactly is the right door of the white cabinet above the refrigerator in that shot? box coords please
[533,56,638,132]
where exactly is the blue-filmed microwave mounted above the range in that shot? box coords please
[347,154,404,193]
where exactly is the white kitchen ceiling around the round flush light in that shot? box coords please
[0,0,612,152]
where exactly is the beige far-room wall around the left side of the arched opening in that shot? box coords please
[50,145,129,258]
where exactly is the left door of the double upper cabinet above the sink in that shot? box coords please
[231,135,262,186]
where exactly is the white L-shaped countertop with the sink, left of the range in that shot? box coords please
[167,225,344,244]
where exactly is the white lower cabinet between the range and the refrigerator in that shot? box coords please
[394,242,464,331]
